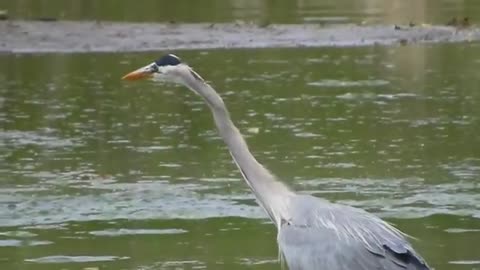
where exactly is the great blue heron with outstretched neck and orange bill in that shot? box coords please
[123,54,429,270]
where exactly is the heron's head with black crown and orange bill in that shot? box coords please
[122,54,199,84]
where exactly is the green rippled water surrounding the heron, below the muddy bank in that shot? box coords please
[0,45,480,269]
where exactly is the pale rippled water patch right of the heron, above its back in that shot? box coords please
[302,178,480,218]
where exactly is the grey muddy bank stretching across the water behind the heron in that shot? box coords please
[0,21,480,53]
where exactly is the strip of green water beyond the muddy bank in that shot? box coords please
[0,0,480,26]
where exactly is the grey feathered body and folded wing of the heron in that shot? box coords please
[278,195,429,270]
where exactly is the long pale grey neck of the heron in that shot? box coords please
[186,73,293,227]
